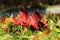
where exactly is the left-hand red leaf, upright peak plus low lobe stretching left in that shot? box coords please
[12,7,30,26]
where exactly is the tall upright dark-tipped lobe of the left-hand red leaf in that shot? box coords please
[19,8,30,25]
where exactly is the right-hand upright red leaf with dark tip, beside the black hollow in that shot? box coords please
[30,10,41,29]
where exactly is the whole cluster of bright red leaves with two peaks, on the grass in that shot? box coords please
[12,8,47,29]
